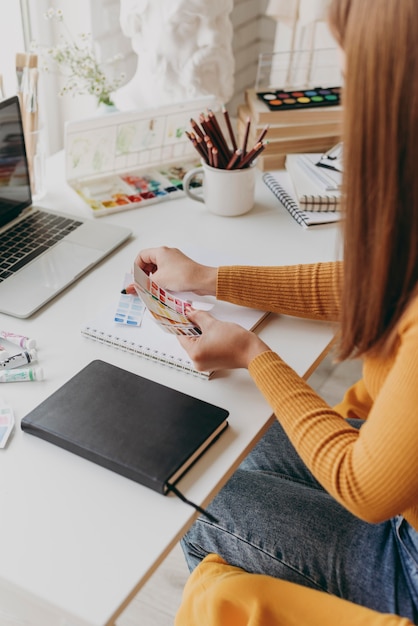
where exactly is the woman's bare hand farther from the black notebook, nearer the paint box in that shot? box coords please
[135,246,218,296]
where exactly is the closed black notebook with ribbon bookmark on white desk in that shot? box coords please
[21,360,228,495]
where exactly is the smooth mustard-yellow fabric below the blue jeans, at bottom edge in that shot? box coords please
[175,554,413,626]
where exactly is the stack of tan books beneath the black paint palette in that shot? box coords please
[237,89,342,171]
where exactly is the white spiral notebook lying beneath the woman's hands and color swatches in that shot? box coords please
[81,286,268,379]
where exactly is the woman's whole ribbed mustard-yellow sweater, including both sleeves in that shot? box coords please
[217,263,418,530]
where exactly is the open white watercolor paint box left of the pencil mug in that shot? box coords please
[65,97,216,217]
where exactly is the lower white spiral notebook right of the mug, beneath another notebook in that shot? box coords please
[263,170,341,228]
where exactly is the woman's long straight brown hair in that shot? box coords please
[329,0,418,358]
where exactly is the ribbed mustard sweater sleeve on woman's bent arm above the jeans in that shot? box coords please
[249,294,418,527]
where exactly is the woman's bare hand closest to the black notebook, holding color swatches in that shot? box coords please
[179,309,270,371]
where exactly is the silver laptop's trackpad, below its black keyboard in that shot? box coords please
[0,241,103,317]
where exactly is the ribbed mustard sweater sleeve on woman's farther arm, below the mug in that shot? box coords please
[216,261,343,321]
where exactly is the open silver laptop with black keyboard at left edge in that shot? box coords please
[0,96,131,318]
